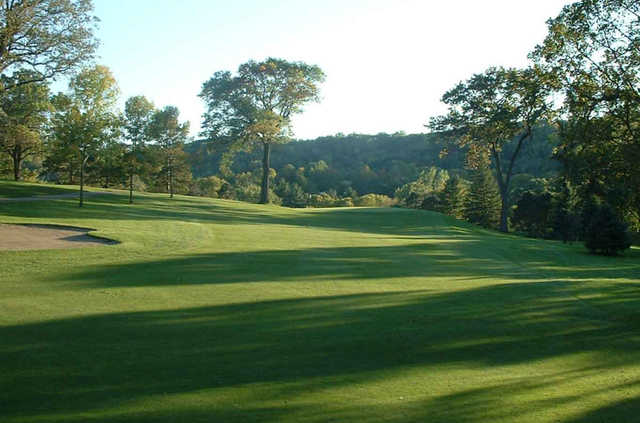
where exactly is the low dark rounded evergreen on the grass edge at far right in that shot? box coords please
[584,205,631,256]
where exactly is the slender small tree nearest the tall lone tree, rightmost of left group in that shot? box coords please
[149,106,189,198]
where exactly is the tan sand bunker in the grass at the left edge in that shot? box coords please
[0,224,117,250]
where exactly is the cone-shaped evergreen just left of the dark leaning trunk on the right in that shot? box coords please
[464,165,500,229]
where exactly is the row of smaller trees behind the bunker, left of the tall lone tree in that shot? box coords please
[0,65,191,206]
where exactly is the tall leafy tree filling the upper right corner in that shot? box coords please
[533,0,640,232]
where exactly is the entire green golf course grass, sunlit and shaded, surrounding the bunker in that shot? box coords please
[0,183,640,423]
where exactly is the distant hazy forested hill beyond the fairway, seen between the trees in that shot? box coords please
[185,127,559,196]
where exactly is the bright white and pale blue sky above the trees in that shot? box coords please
[89,0,570,139]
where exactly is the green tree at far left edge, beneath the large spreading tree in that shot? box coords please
[0,71,52,181]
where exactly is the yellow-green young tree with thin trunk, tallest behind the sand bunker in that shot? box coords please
[48,65,120,207]
